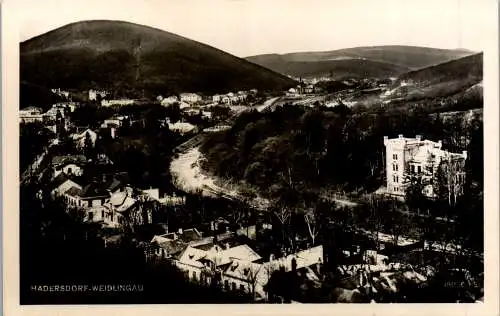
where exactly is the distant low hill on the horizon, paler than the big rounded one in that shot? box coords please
[246,46,474,77]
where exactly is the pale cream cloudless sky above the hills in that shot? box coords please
[12,0,497,57]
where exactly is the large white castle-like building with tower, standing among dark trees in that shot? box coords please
[384,135,467,198]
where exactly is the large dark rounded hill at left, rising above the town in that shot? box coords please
[20,20,294,96]
